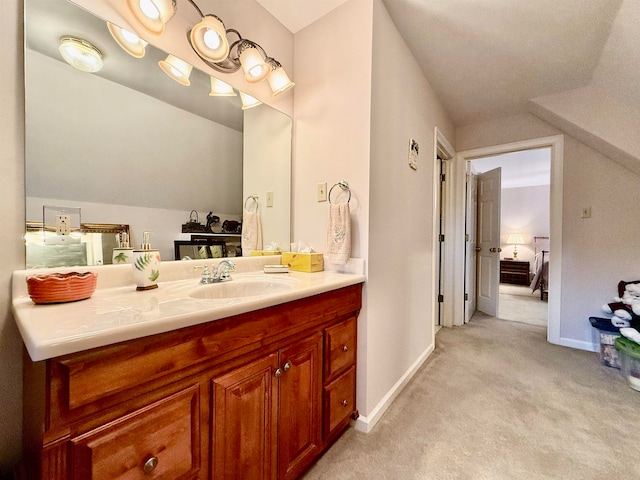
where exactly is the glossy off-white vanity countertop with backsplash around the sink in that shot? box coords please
[12,257,365,361]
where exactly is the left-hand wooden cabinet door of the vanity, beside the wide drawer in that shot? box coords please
[210,353,278,480]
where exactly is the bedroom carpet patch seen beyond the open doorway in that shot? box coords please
[498,283,549,326]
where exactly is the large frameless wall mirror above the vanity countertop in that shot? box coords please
[25,0,291,267]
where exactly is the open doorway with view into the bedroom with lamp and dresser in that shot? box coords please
[467,147,551,327]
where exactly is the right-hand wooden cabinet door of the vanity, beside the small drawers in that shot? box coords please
[278,333,322,479]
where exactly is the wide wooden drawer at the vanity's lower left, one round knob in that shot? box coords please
[70,385,200,480]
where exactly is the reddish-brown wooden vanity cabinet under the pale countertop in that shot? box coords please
[23,284,362,480]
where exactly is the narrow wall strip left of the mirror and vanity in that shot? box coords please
[0,2,24,477]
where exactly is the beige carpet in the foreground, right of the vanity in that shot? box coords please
[303,315,640,480]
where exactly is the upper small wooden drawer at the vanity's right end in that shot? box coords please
[324,318,356,381]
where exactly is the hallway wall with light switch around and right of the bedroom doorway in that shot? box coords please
[456,115,640,349]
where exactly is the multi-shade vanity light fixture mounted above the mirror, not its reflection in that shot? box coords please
[127,0,295,96]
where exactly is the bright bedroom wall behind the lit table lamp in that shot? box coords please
[500,185,551,268]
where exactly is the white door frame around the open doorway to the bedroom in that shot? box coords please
[450,135,564,345]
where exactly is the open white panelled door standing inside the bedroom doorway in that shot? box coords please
[476,168,501,317]
